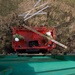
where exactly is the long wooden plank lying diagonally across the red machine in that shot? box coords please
[23,25,67,49]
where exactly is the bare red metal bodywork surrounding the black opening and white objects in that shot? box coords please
[12,27,56,51]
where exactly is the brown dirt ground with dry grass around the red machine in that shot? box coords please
[0,0,75,54]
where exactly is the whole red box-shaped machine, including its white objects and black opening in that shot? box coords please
[12,27,56,53]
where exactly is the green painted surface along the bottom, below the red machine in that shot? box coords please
[0,55,75,75]
